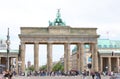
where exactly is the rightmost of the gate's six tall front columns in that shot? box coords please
[91,43,98,71]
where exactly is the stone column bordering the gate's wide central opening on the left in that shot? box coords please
[47,43,52,73]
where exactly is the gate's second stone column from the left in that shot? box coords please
[34,42,39,71]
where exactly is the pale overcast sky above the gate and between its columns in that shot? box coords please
[0,0,120,64]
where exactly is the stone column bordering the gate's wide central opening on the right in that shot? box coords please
[64,43,70,73]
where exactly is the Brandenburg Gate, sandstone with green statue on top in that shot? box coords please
[19,11,99,72]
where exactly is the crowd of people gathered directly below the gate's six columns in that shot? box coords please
[20,70,101,79]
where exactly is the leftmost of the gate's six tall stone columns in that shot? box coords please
[20,42,25,72]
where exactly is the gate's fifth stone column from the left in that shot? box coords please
[78,43,84,71]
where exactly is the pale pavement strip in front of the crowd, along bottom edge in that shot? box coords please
[12,76,110,79]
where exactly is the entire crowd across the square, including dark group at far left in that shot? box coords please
[2,70,115,79]
